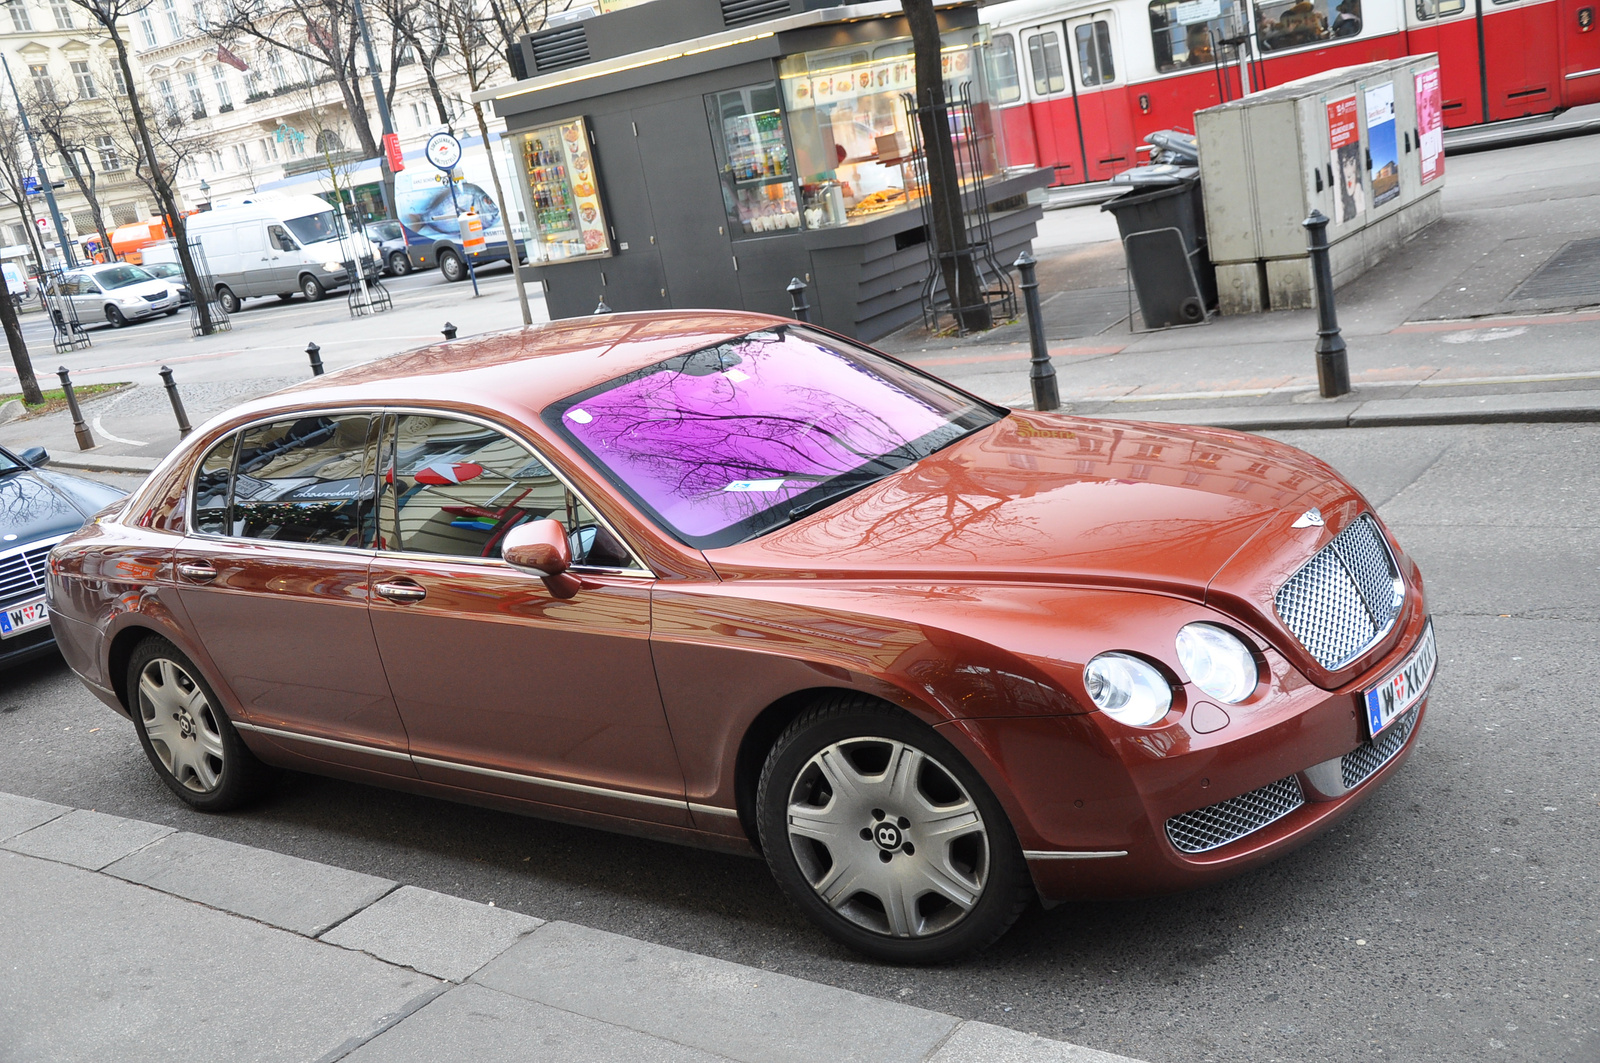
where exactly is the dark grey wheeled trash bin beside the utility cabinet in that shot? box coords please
[1101,163,1216,328]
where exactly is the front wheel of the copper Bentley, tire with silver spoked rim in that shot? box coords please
[755,693,1034,964]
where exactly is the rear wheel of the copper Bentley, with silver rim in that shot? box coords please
[128,636,272,812]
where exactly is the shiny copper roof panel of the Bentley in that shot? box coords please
[248,311,795,421]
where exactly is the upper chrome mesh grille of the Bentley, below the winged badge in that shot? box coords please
[1274,514,1402,671]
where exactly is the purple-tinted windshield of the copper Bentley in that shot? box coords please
[544,327,1002,549]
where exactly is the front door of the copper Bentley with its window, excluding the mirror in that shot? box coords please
[371,413,688,824]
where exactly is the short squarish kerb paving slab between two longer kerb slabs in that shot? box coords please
[322,885,544,981]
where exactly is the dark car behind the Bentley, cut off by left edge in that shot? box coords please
[0,447,123,668]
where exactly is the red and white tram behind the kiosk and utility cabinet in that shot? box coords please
[982,0,1600,184]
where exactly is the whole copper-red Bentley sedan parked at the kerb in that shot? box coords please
[48,311,1435,962]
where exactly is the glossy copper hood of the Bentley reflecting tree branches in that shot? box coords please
[706,411,1349,600]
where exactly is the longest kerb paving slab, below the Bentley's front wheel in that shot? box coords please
[474,922,957,1063]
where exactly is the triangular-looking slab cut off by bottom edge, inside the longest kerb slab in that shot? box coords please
[342,985,728,1063]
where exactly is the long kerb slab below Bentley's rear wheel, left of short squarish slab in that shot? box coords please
[106,831,397,937]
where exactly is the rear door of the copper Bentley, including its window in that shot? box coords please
[174,411,416,776]
